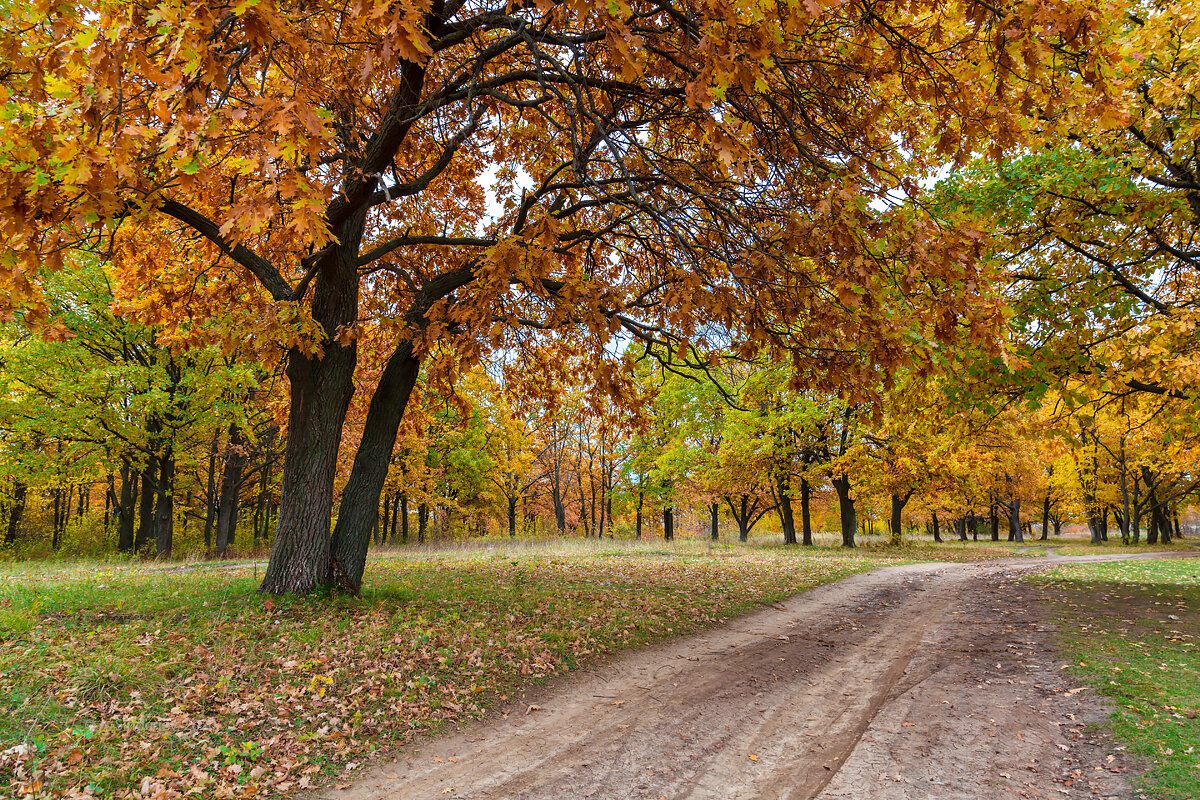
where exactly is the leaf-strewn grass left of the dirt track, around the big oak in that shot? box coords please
[0,539,1080,798]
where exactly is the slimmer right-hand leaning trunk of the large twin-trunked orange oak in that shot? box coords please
[332,342,421,594]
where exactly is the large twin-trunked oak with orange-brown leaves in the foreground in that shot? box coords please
[0,0,1091,593]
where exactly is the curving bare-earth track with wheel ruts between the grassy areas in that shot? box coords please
[325,553,1194,800]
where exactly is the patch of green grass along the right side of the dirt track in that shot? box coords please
[1039,559,1200,800]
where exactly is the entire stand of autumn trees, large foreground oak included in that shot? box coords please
[0,0,1200,593]
